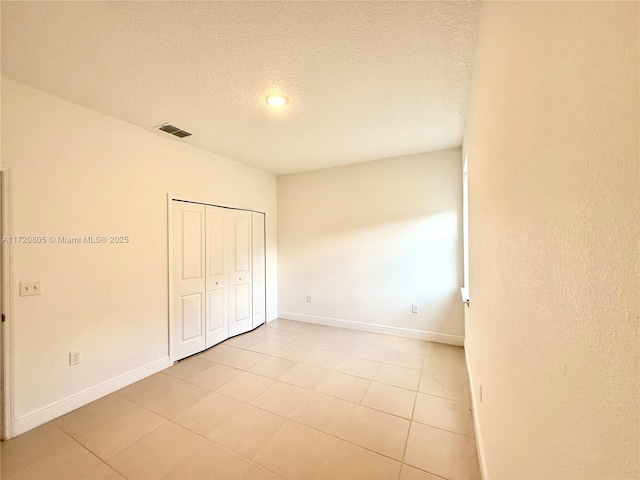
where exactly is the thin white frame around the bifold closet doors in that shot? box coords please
[167,193,267,363]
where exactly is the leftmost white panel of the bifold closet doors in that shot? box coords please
[172,202,205,360]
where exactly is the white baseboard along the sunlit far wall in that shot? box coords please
[278,312,464,347]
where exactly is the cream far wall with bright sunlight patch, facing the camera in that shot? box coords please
[278,149,464,343]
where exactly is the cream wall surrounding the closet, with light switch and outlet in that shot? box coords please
[2,78,277,432]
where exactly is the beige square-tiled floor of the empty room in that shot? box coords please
[1,319,480,479]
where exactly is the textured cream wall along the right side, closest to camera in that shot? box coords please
[464,2,640,479]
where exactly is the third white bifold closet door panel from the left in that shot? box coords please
[227,209,253,336]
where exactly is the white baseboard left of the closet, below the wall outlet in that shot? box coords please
[13,356,171,436]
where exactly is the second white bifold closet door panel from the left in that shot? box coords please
[205,205,229,348]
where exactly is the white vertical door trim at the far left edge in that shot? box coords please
[0,164,15,439]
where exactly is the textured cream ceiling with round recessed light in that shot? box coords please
[2,1,479,174]
